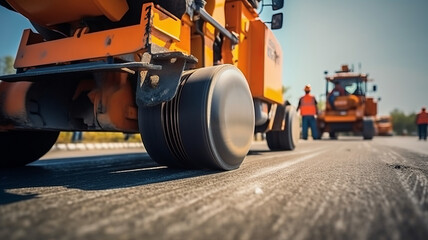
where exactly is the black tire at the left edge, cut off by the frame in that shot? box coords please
[0,131,59,168]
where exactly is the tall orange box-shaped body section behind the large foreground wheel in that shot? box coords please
[223,1,284,104]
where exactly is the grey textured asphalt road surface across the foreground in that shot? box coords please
[0,137,428,240]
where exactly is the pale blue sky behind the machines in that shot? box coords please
[0,0,428,115]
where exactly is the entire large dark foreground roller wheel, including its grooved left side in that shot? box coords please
[138,65,254,170]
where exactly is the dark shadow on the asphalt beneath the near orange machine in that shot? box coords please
[0,153,219,205]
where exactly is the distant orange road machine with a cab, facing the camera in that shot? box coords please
[317,65,377,139]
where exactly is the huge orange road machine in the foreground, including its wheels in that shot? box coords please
[0,0,299,170]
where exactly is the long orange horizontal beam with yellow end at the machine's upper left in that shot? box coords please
[15,4,186,68]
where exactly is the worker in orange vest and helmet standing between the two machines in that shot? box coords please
[297,84,318,140]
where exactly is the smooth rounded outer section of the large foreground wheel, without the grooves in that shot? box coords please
[180,65,254,170]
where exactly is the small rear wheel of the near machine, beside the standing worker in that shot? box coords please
[266,105,300,151]
